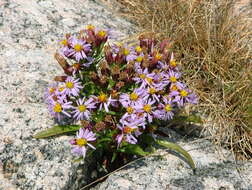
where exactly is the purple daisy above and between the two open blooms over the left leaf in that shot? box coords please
[62,76,83,96]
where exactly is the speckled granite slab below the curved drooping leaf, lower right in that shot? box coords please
[92,132,252,190]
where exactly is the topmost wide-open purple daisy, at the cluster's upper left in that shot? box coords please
[68,37,91,62]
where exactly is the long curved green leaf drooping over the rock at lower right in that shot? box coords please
[156,140,196,170]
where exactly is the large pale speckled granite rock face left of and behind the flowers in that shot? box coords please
[0,0,136,190]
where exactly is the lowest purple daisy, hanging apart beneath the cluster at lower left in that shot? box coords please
[70,128,96,158]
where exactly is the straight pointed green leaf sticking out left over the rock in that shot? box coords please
[34,125,81,139]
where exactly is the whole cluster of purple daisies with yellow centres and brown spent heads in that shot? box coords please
[45,25,197,157]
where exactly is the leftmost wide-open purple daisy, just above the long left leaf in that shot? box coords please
[48,99,72,121]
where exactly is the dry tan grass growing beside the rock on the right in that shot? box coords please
[103,0,252,159]
